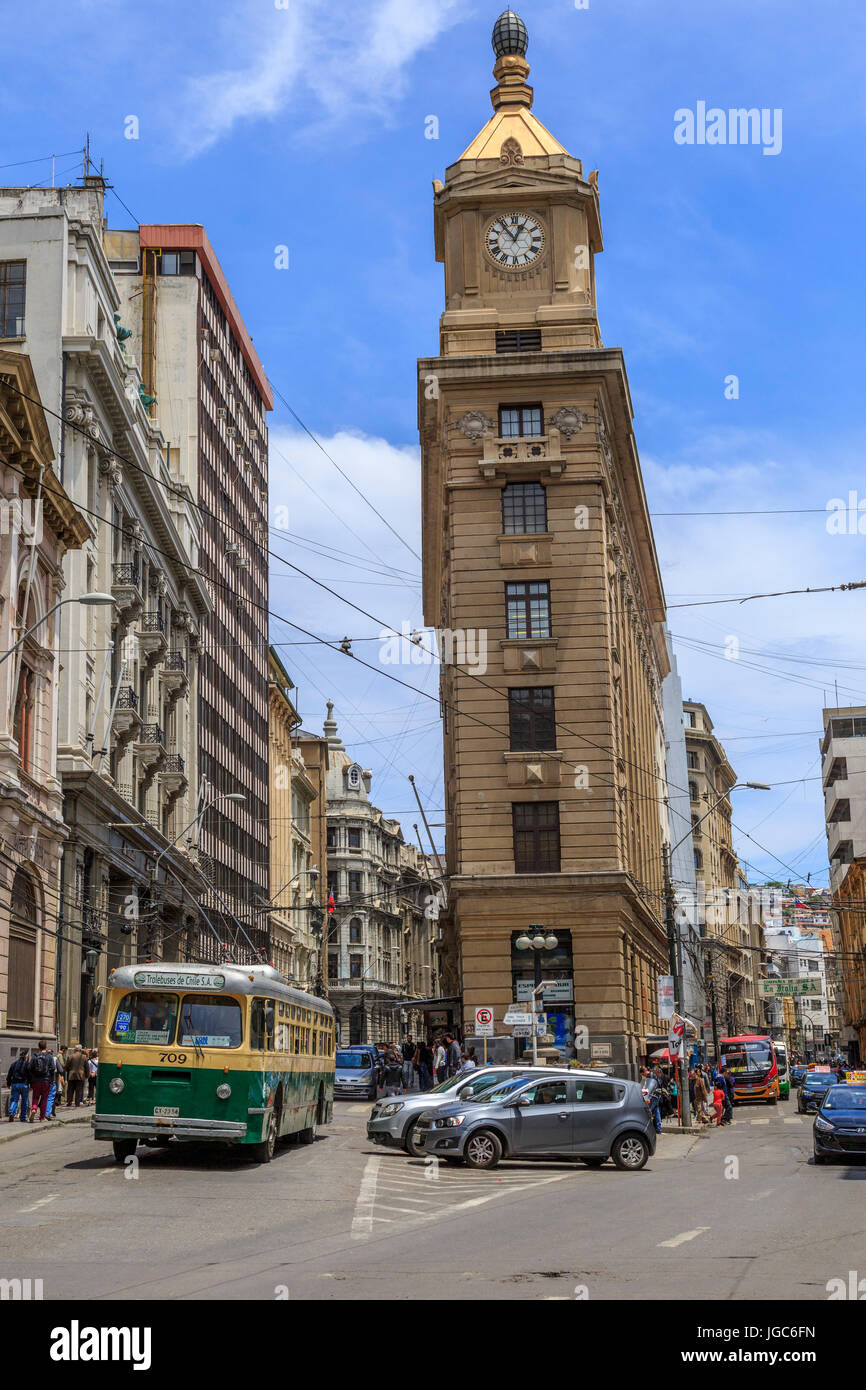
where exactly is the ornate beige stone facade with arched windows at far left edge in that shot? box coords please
[0,349,89,1061]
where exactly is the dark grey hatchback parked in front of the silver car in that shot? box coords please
[417,1072,656,1172]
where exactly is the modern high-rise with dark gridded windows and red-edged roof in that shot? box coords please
[106,225,272,949]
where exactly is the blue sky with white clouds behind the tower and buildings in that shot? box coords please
[0,0,866,883]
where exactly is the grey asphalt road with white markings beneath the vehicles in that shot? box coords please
[0,1102,866,1301]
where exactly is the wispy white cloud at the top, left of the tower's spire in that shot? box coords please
[172,0,461,156]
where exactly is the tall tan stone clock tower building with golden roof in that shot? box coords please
[418,10,669,1074]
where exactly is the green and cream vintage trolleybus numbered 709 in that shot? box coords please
[93,962,335,1163]
